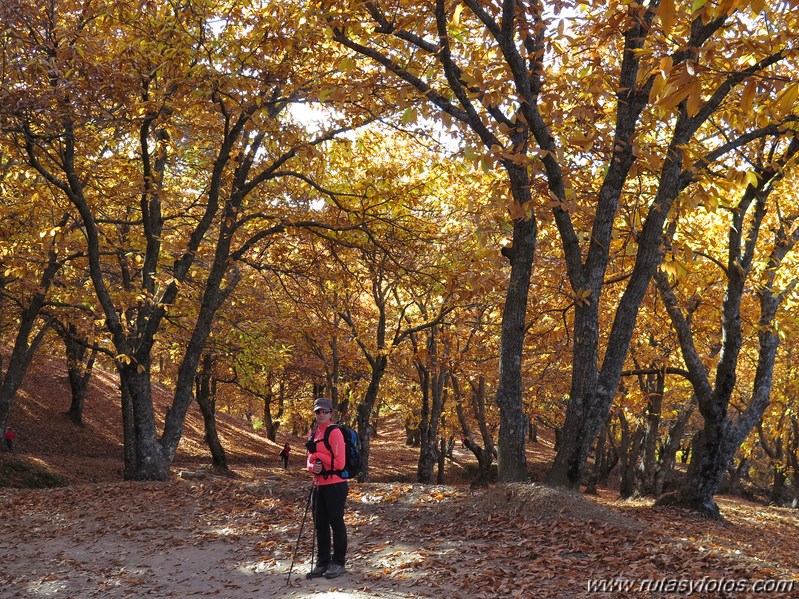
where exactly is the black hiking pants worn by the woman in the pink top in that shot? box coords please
[313,481,349,566]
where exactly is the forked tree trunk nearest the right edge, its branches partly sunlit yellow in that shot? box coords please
[656,137,799,518]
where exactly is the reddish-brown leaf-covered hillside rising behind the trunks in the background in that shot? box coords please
[0,356,438,486]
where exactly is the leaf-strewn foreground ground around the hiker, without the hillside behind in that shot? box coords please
[0,475,799,599]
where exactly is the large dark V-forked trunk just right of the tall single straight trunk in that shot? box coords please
[547,12,752,488]
